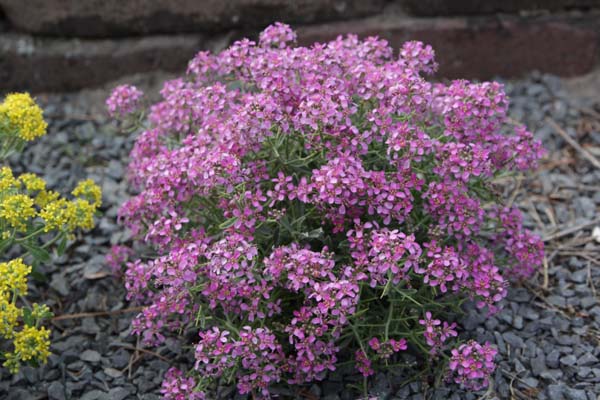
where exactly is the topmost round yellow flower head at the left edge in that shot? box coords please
[0,93,48,141]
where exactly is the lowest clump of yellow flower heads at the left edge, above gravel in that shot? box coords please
[0,258,50,373]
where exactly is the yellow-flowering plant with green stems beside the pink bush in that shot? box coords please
[0,93,102,373]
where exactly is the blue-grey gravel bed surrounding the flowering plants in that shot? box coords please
[0,74,600,400]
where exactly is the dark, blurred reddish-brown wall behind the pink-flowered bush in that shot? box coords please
[0,0,600,91]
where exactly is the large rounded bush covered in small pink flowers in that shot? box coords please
[111,24,543,399]
